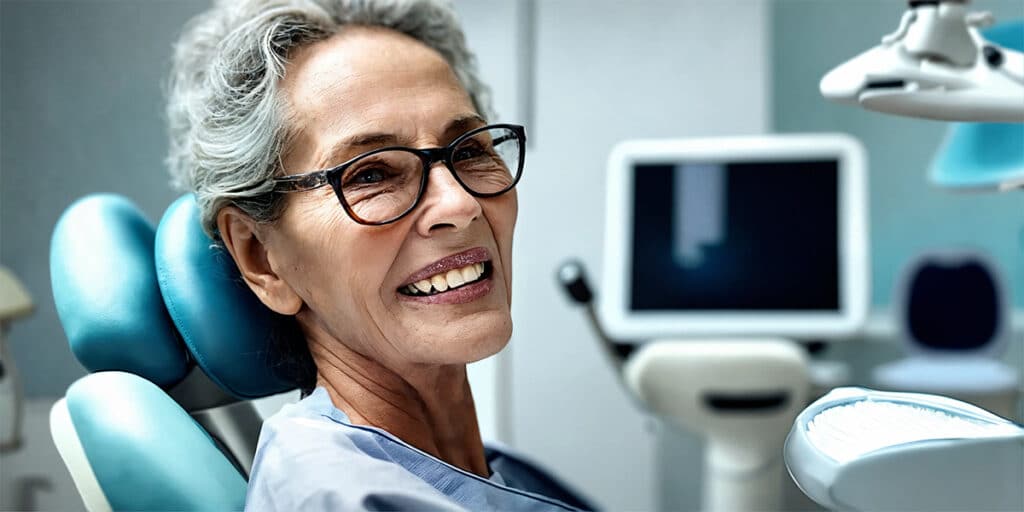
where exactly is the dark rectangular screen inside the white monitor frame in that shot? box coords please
[629,159,841,312]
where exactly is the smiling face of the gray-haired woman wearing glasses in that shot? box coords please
[261,28,517,368]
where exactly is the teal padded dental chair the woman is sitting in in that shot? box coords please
[50,195,594,512]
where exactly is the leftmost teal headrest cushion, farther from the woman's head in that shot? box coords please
[50,195,189,387]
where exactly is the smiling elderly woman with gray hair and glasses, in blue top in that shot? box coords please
[168,0,593,511]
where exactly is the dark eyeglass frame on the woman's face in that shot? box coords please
[273,123,526,225]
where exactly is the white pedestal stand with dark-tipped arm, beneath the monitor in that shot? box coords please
[557,261,809,512]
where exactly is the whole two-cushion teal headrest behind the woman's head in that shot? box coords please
[50,195,294,398]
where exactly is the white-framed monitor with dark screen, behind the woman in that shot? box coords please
[598,134,868,342]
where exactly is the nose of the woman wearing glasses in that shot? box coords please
[417,162,481,237]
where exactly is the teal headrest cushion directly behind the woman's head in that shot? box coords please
[156,194,295,398]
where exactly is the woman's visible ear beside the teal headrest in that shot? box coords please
[217,206,302,315]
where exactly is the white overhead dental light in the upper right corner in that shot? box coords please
[820,0,1024,123]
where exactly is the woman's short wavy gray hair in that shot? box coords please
[167,0,492,241]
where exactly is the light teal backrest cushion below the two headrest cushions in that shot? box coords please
[67,372,246,510]
